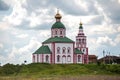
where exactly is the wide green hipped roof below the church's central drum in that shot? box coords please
[43,36,74,43]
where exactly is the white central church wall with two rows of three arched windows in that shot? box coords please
[55,43,73,64]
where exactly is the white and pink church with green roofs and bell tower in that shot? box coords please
[32,11,89,64]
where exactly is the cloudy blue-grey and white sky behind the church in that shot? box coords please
[0,0,120,65]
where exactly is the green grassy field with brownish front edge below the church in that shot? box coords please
[0,63,120,80]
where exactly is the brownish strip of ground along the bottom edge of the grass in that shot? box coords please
[0,75,120,80]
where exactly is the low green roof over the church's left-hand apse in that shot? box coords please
[33,46,51,54]
